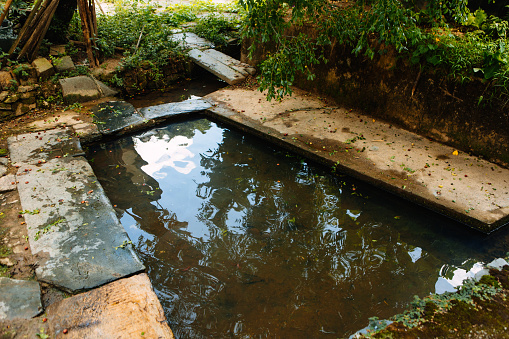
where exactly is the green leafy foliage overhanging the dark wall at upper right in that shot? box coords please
[241,0,509,99]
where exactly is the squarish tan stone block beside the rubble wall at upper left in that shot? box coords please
[59,75,101,104]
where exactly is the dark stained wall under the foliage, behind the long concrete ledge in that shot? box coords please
[242,36,509,167]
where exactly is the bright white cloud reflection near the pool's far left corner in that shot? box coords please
[133,135,196,179]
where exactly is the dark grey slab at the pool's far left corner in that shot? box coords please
[90,101,144,135]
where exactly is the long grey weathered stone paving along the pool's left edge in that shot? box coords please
[8,130,144,291]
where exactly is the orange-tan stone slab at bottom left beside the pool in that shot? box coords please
[47,274,174,339]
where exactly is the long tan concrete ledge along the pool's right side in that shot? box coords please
[207,88,509,232]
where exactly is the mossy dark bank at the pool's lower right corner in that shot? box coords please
[355,266,509,338]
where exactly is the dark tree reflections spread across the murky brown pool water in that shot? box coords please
[89,120,490,338]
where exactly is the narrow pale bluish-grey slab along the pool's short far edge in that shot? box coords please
[140,98,212,119]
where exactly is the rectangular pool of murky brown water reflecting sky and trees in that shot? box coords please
[87,119,508,338]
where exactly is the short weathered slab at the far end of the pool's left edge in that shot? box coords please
[7,128,83,165]
